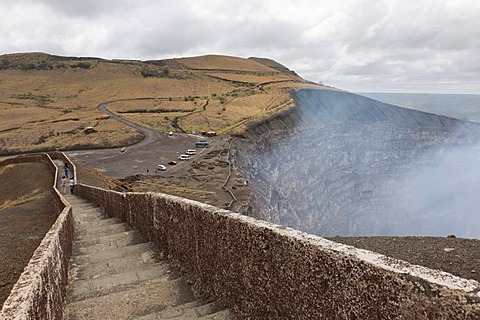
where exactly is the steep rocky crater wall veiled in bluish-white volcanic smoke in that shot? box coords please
[235,90,480,237]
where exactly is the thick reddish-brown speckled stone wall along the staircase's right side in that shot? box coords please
[76,184,480,320]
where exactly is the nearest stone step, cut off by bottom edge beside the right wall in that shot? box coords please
[135,300,231,320]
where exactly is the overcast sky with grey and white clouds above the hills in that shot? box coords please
[0,0,480,94]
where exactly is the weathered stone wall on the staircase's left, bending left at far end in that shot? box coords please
[0,154,73,320]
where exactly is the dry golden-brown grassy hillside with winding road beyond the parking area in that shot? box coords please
[0,53,322,154]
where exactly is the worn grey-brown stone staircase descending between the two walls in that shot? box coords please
[64,194,238,320]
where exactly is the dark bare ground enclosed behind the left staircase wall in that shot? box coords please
[0,163,58,304]
